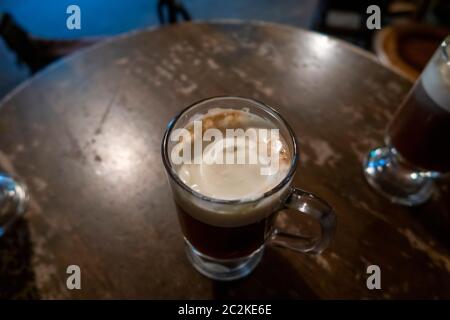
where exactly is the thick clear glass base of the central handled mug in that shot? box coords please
[184,239,264,281]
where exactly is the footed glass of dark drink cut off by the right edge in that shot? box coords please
[363,36,450,206]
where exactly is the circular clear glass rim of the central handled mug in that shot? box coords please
[161,95,299,205]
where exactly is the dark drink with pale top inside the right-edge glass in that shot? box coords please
[388,49,450,173]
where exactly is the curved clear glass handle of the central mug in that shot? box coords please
[269,187,336,254]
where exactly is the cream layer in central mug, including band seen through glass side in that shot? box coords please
[171,108,292,227]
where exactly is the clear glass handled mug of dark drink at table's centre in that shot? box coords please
[162,97,336,280]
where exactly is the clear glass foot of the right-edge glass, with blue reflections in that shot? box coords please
[363,147,434,206]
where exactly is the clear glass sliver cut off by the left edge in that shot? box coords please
[0,172,28,237]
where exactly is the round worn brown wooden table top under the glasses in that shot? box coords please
[0,22,450,299]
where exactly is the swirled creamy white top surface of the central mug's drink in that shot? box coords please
[178,109,290,200]
